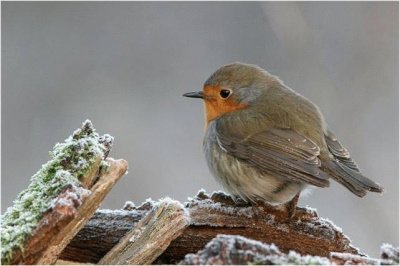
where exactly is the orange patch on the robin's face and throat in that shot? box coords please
[203,86,247,125]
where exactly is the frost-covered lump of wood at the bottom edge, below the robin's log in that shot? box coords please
[180,235,330,265]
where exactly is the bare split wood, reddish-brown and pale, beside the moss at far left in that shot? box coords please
[17,158,128,264]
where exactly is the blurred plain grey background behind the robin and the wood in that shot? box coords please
[1,2,399,256]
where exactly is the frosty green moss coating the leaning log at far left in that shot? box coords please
[1,120,111,264]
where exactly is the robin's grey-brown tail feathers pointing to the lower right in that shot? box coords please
[323,160,383,197]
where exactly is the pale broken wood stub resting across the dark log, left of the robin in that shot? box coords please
[99,199,189,265]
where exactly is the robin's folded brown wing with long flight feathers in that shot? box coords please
[217,128,329,187]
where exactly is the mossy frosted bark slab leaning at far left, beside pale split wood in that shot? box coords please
[1,120,125,264]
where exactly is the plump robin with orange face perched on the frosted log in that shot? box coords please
[183,62,383,217]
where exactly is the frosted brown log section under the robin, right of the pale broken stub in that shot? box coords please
[157,189,358,263]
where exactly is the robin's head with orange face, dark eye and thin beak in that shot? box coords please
[183,63,279,124]
